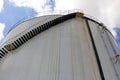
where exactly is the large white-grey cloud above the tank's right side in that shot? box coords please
[55,0,120,35]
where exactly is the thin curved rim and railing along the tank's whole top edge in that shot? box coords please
[2,10,115,44]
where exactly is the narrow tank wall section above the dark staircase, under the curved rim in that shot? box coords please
[3,15,61,43]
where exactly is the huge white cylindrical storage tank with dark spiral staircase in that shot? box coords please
[0,10,120,80]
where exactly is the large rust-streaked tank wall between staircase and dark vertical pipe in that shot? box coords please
[0,18,101,80]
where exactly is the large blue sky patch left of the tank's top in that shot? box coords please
[0,0,36,36]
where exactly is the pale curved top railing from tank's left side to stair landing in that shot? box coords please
[7,9,83,34]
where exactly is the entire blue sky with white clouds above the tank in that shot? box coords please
[0,0,120,46]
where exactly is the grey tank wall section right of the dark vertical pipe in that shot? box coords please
[89,21,120,80]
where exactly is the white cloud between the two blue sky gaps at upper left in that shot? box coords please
[9,0,50,12]
